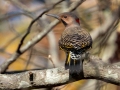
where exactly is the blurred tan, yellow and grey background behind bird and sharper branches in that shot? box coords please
[0,0,120,90]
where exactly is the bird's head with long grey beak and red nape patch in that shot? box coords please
[46,12,80,26]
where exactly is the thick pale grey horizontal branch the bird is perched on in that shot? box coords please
[0,54,120,89]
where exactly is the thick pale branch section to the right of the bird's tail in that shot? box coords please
[83,56,120,85]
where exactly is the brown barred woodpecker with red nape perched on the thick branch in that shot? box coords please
[46,12,92,73]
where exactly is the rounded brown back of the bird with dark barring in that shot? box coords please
[59,26,92,51]
